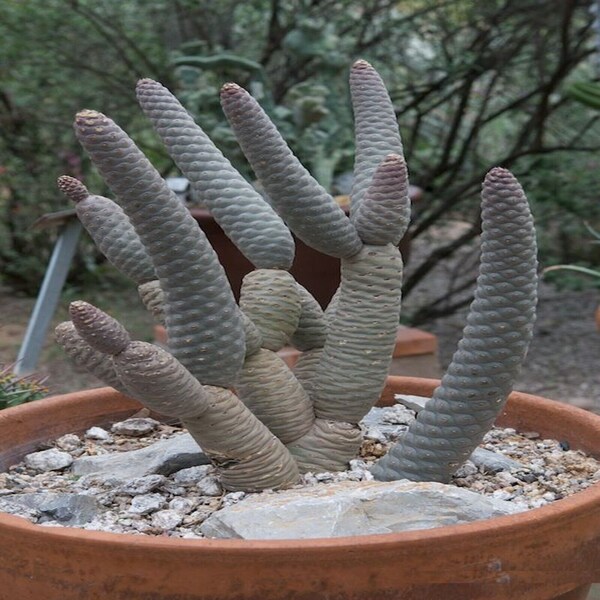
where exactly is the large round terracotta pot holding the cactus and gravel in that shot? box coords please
[0,377,600,600]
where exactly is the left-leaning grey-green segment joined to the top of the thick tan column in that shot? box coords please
[221,83,362,258]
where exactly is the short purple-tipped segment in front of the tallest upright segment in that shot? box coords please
[354,154,410,246]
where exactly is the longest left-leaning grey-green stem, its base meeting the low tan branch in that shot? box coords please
[75,111,245,386]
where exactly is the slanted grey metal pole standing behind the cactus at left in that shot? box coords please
[13,219,81,375]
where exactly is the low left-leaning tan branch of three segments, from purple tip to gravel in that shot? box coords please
[70,302,298,491]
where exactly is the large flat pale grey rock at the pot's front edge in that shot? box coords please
[200,481,519,539]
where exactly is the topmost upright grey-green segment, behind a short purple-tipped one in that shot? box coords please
[350,60,403,220]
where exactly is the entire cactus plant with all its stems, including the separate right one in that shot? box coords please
[56,60,536,491]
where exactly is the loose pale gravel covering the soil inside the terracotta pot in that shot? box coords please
[0,405,600,538]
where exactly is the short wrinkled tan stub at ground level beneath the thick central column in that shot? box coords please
[287,419,362,473]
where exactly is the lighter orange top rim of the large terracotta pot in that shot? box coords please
[0,376,600,553]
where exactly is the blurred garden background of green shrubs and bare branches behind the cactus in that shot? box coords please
[0,0,600,411]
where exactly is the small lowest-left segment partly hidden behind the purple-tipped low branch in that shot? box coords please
[54,321,129,395]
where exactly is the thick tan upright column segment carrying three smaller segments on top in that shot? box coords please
[313,244,402,423]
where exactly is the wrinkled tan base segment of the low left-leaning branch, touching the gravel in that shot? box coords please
[183,386,299,492]
